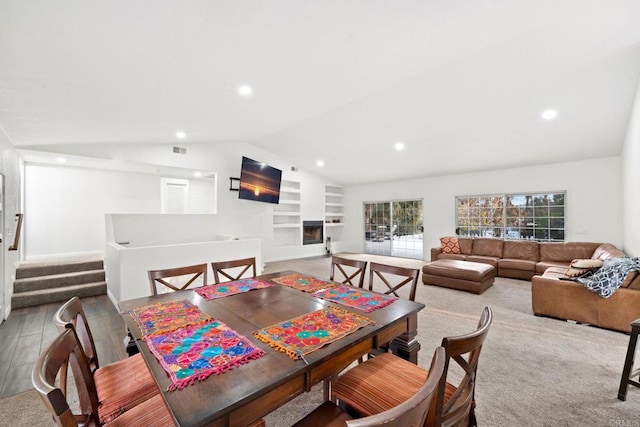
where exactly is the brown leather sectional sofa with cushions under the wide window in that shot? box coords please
[431,237,640,332]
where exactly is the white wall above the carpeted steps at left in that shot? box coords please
[24,164,160,259]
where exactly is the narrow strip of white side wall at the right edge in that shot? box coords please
[622,77,640,257]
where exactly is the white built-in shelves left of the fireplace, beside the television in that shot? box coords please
[273,180,302,246]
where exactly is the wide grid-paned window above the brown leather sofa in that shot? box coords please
[456,193,565,242]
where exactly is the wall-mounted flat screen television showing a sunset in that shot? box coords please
[238,156,282,203]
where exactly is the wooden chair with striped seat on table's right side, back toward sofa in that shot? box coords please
[331,307,493,427]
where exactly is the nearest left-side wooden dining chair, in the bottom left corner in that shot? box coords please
[31,328,175,427]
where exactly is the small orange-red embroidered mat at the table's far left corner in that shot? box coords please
[129,300,213,337]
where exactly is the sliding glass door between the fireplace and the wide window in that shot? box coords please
[364,200,423,259]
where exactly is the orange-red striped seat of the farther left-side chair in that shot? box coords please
[93,354,160,423]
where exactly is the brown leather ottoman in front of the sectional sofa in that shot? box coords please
[422,259,496,294]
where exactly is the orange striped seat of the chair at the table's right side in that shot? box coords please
[331,353,455,416]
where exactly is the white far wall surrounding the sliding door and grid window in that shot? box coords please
[344,157,622,260]
